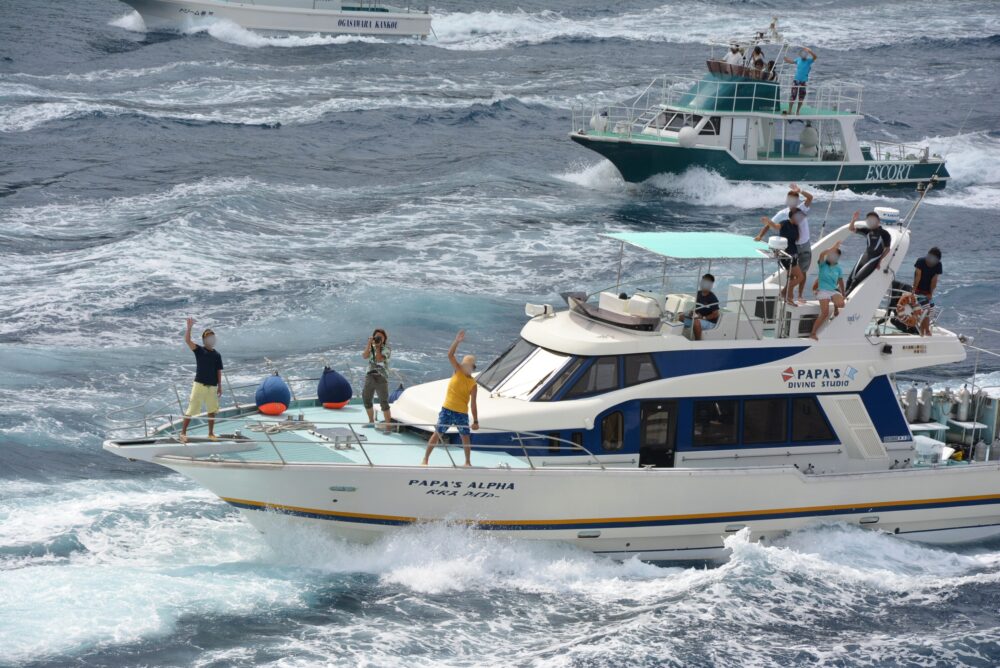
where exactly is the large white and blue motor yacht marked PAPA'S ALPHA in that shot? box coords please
[104,181,1000,561]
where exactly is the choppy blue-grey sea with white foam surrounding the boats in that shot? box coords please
[0,0,1000,666]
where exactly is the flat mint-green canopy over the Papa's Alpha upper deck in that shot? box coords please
[604,232,772,260]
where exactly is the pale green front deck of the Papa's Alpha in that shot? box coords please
[156,404,529,468]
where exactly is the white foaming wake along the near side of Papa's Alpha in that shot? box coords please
[0,476,1000,665]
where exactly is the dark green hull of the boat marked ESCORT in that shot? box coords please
[570,132,949,190]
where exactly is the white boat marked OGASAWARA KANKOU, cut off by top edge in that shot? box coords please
[122,0,431,37]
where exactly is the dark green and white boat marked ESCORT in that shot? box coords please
[570,23,949,190]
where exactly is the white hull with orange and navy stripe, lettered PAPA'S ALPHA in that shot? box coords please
[155,456,1000,561]
